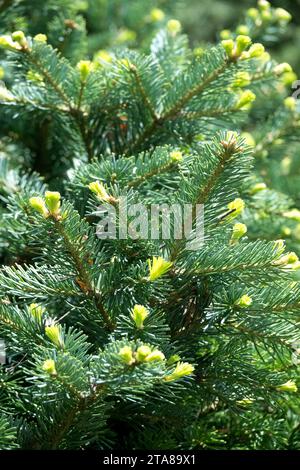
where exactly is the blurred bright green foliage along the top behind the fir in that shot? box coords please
[0,0,300,67]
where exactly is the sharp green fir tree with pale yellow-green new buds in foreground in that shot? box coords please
[0,1,300,449]
